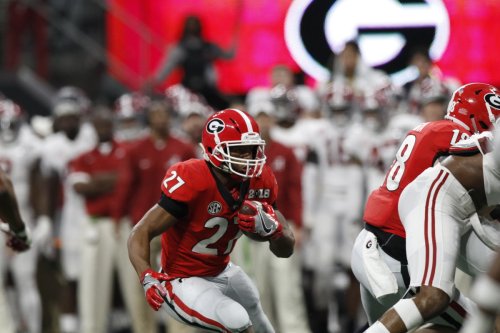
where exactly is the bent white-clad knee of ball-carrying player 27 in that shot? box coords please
[215,300,252,333]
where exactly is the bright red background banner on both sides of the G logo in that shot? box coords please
[107,0,500,94]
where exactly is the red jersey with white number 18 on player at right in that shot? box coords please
[363,120,470,237]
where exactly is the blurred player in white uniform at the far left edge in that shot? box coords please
[0,99,46,333]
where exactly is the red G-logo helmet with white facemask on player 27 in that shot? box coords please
[201,109,266,178]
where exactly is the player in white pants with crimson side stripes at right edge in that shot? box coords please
[366,88,500,333]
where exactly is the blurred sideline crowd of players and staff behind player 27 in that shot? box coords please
[0,33,464,333]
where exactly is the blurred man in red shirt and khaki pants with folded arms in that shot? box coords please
[68,107,155,333]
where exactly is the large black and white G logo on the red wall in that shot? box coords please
[285,0,450,81]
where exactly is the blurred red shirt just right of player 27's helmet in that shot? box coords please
[266,141,302,227]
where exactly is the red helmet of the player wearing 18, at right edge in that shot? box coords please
[445,83,500,133]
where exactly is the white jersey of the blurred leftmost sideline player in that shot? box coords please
[0,126,41,221]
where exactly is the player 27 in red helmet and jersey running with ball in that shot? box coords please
[129,109,295,333]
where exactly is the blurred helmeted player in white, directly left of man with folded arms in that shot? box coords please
[40,87,97,333]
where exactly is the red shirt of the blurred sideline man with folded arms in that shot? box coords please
[69,141,131,219]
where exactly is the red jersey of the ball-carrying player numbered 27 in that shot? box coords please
[161,159,278,278]
